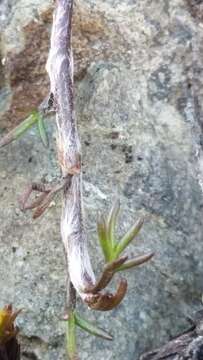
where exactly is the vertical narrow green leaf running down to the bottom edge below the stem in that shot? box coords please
[67,312,77,360]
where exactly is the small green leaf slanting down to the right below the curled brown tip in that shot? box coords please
[75,313,113,340]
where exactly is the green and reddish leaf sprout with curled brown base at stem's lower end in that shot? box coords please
[84,202,153,311]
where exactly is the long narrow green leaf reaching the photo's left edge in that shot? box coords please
[0,112,37,147]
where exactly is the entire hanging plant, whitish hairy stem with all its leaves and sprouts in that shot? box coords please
[0,0,153,360]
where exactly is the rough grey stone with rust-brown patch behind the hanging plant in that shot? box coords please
[0,0,203,360]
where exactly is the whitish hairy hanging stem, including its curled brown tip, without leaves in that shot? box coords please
[47,0,127,310]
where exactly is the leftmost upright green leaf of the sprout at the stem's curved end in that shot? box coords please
[97,215,112,261]
